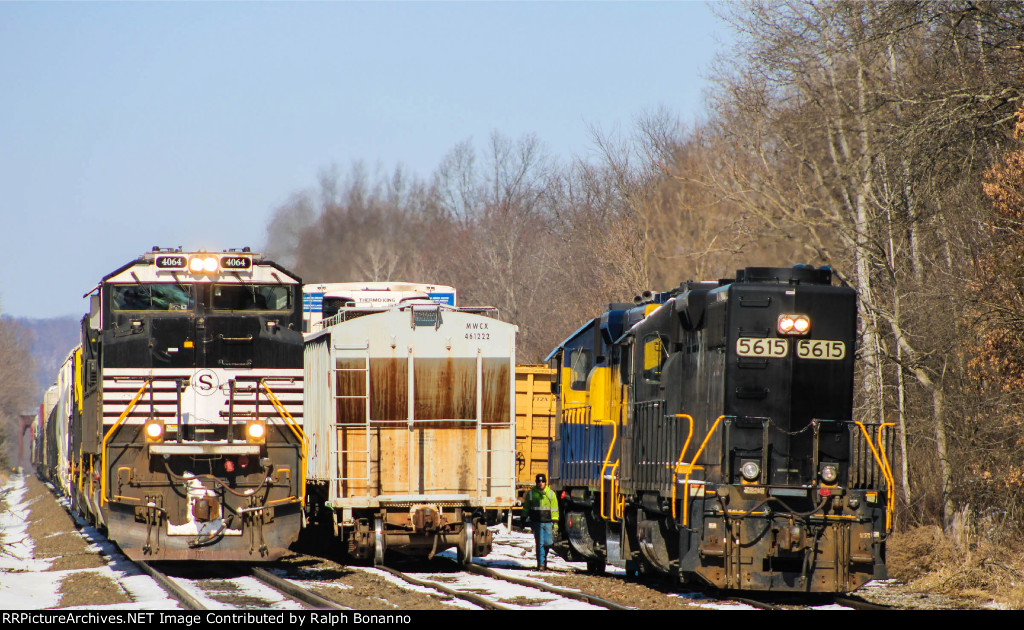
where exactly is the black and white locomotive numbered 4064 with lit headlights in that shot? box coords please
[37,248,306,561]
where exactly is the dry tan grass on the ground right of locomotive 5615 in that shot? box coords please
[886,517,1024,610]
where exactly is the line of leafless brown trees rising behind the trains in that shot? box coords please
[267,0,1024,534]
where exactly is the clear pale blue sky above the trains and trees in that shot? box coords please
[0,2,728,318]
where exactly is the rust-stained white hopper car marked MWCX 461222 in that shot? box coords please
[305,300,517,563]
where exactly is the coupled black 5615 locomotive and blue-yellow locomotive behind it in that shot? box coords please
[549,265,893,592]
